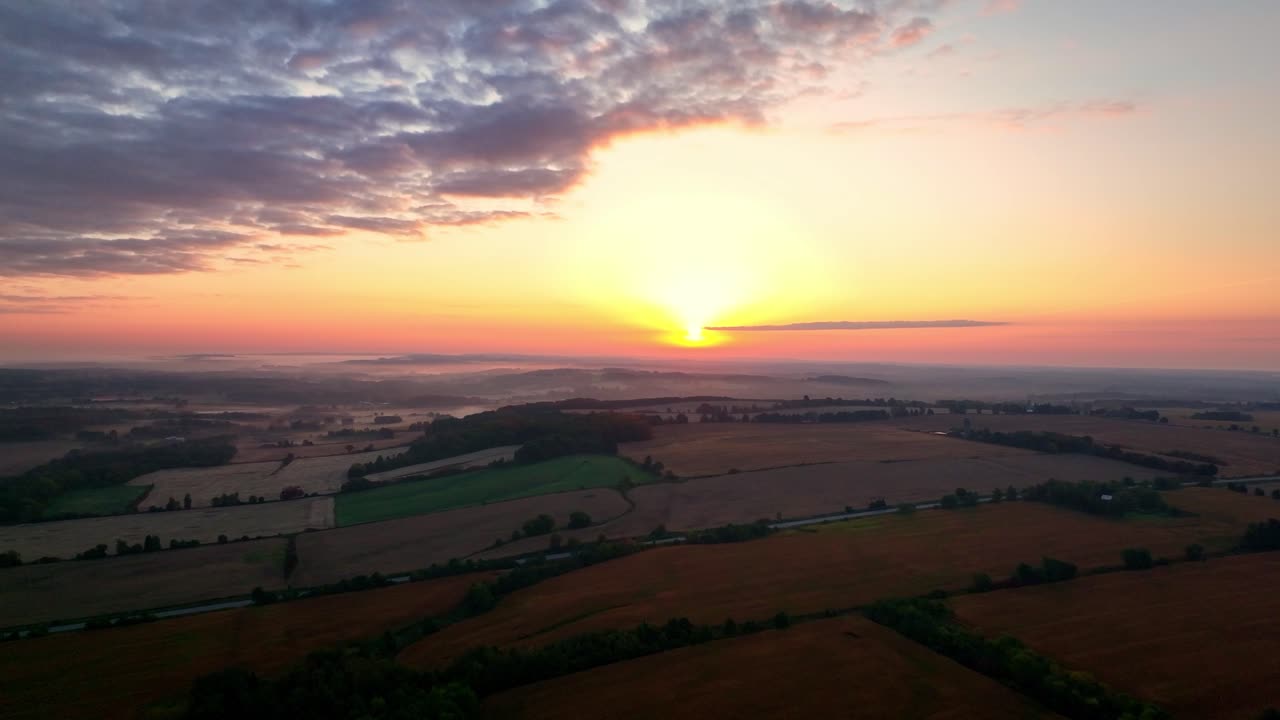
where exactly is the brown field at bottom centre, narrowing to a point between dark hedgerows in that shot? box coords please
[485,609,1056,720]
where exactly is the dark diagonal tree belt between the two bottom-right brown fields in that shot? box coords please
[867,600,1169,720]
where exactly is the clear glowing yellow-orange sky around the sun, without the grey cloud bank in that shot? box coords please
[0,1,1280,369]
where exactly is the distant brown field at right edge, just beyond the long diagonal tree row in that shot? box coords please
[896,415,1280,477]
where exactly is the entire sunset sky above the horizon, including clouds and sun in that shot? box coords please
[0,0,1280,370]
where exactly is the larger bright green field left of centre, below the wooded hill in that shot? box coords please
[334,455,653,528]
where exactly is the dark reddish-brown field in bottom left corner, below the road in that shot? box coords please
[0,575,484,720]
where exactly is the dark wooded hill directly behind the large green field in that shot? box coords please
[347,409,653,479]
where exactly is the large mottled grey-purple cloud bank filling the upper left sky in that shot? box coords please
[0,0,946,277]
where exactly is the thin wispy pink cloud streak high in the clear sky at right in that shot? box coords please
[829,100,1140,133]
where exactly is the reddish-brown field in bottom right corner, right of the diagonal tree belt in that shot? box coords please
[952,552,1280,720]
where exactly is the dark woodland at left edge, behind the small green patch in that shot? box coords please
[0,437,236,523]
